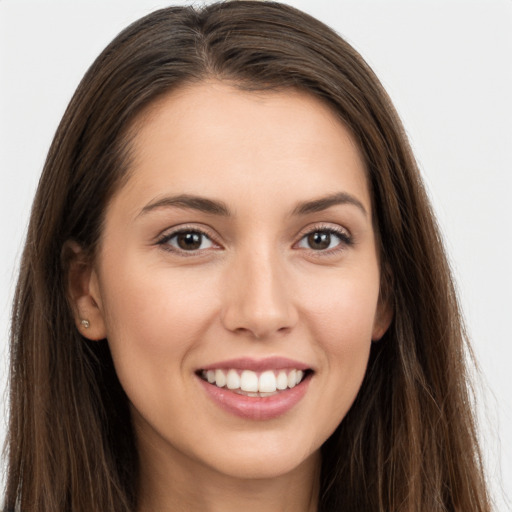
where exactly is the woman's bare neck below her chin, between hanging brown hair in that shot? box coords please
[138,440,320,512]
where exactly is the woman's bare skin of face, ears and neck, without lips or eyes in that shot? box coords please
[70,81,391,512]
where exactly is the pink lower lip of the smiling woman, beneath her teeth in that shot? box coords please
[198,375,311,421]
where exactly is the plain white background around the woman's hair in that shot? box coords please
[0,0,512,511]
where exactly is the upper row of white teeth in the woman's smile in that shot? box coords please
[202,369,304,393]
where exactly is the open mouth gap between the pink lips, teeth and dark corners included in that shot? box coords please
[197,368,312,398]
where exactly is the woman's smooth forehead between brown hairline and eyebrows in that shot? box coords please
[112,81,371,218]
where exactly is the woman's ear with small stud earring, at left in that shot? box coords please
[62,241,107,341]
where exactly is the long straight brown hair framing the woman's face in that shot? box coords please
[5,1,490,512]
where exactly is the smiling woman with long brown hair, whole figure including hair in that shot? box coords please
[6,1,489,512]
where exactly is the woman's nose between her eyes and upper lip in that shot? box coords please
[221,245,298,339]
